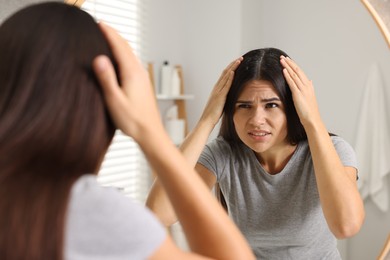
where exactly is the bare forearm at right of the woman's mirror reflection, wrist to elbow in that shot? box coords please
[306,123,364,238]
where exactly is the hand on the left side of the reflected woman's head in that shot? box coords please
[201,57,243,126]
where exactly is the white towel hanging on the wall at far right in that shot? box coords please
[355,63,390,212]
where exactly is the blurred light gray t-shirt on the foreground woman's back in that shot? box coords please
[64,175,167,260]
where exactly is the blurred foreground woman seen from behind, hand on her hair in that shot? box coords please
[0,3,253,260]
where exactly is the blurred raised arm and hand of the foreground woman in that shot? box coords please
[93,22,254,259]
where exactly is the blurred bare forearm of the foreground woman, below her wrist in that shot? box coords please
[139,127,253,259]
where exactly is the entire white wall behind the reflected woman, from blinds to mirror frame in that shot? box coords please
[147,0,390,260]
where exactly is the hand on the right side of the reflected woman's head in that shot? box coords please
[280,56,321,127]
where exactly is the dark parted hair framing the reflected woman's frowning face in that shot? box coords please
[219,48,307,145]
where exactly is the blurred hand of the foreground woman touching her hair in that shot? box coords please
[93,23,164,142]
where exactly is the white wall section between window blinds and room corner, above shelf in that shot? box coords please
[147,0,241,136]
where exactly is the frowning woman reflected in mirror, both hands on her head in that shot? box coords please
[147,48,364,259]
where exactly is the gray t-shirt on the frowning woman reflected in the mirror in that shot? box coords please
[198,137,357,260]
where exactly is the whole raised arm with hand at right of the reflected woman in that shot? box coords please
[280,56,364,239]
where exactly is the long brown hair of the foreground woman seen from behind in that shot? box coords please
[0,2,115,260]
